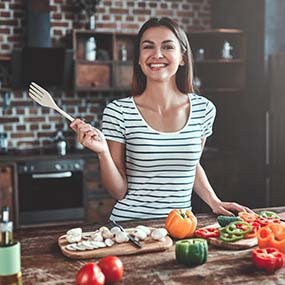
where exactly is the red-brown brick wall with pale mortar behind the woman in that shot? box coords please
[0,0,211,149]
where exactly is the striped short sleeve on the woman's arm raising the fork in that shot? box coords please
[102,101,125,143]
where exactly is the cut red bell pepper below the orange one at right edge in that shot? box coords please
[252,247,284,272]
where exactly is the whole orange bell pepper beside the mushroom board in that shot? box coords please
[165,209,197,239]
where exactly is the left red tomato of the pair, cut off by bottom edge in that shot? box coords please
[76,262,105,285]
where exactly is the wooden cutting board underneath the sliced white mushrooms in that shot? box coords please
[58,232,173,259]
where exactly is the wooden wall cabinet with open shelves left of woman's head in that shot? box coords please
[73,30,135,91]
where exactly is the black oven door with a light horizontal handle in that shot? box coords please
[18,168,84,225]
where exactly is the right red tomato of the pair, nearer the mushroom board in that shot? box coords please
[98,256,124,284]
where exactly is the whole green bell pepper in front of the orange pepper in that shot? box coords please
[175,238,208,266]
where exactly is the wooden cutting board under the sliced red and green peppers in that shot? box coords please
[204,223,257,250]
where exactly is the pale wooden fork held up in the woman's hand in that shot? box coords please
[29,82,74,122]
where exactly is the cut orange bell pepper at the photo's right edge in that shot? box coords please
[257,223,285,253]
